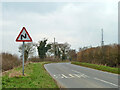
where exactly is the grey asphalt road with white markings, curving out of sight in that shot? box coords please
[44,63,118,88]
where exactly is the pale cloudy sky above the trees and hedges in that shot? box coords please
[0,1,118,55]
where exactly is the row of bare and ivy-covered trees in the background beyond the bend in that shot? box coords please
[19,38,77,62]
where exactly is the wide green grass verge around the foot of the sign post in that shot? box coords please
[2,62,58,88]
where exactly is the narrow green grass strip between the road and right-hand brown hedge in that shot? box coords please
[71,61,120,74]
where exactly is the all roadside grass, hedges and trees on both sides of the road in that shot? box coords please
[0,38,120,88]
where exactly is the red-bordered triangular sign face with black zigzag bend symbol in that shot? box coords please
[16,27,32,42]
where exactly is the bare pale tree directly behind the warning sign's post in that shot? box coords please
[19,43,35,61]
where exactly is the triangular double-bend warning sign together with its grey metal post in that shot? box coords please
[16,27,32,75]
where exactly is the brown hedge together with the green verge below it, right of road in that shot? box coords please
[75,44,120,74]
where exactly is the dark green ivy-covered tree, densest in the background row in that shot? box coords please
[37,39,51,59]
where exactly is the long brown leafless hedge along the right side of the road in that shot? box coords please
[77,44,120,67]
